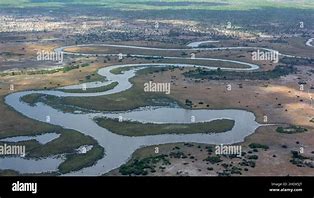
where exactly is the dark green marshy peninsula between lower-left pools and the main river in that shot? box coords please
[0,129,104,174]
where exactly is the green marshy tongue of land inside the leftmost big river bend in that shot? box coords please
[21,71,179,111]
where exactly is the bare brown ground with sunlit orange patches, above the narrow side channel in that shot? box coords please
[143,67,314,127]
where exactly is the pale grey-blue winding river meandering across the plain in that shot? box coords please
[0,38,312,175]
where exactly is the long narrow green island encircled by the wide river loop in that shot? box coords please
[95,118,234,136]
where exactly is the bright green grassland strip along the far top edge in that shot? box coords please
[0,0,314,10]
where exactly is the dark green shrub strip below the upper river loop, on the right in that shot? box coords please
[184,66,297,80]
